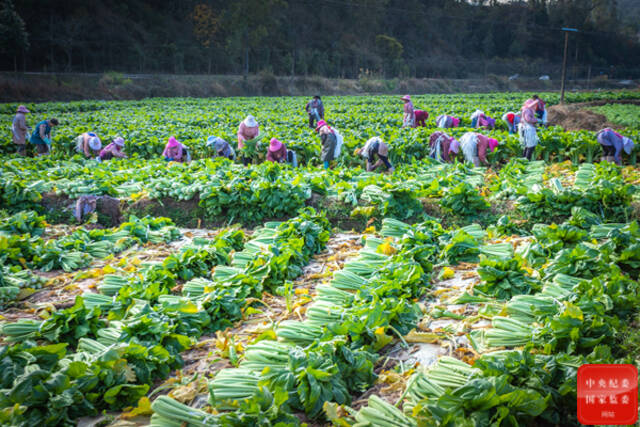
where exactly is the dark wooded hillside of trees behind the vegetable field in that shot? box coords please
[0,0,640,78]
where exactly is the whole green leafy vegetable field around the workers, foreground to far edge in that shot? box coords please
[0,91,640,427]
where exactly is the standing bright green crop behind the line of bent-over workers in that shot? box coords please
[0,91,640,164]
